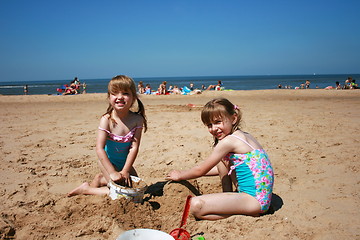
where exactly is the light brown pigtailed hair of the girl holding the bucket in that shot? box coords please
[104,75,147,132]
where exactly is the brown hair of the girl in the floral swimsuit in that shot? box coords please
[201,98,242,145]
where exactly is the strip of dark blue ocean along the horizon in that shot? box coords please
[0,74,360,95]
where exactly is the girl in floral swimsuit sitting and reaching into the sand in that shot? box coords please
[166,98,274,220]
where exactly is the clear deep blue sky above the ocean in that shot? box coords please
[0,0,360,81]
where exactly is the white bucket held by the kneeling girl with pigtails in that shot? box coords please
[108,176,147,203]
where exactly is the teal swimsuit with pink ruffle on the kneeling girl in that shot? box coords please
[99,127,142,171]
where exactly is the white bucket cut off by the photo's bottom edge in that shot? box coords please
[116,229,174,240]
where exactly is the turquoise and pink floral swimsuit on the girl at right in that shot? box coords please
[224,135,274,213]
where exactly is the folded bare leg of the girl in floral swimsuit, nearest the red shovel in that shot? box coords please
[190,192,261,220]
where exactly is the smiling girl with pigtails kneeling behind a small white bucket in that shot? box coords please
[68,75,147,197]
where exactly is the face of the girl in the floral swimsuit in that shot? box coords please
[207,114,236,140]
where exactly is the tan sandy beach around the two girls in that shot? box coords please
[0,89,360,240]
